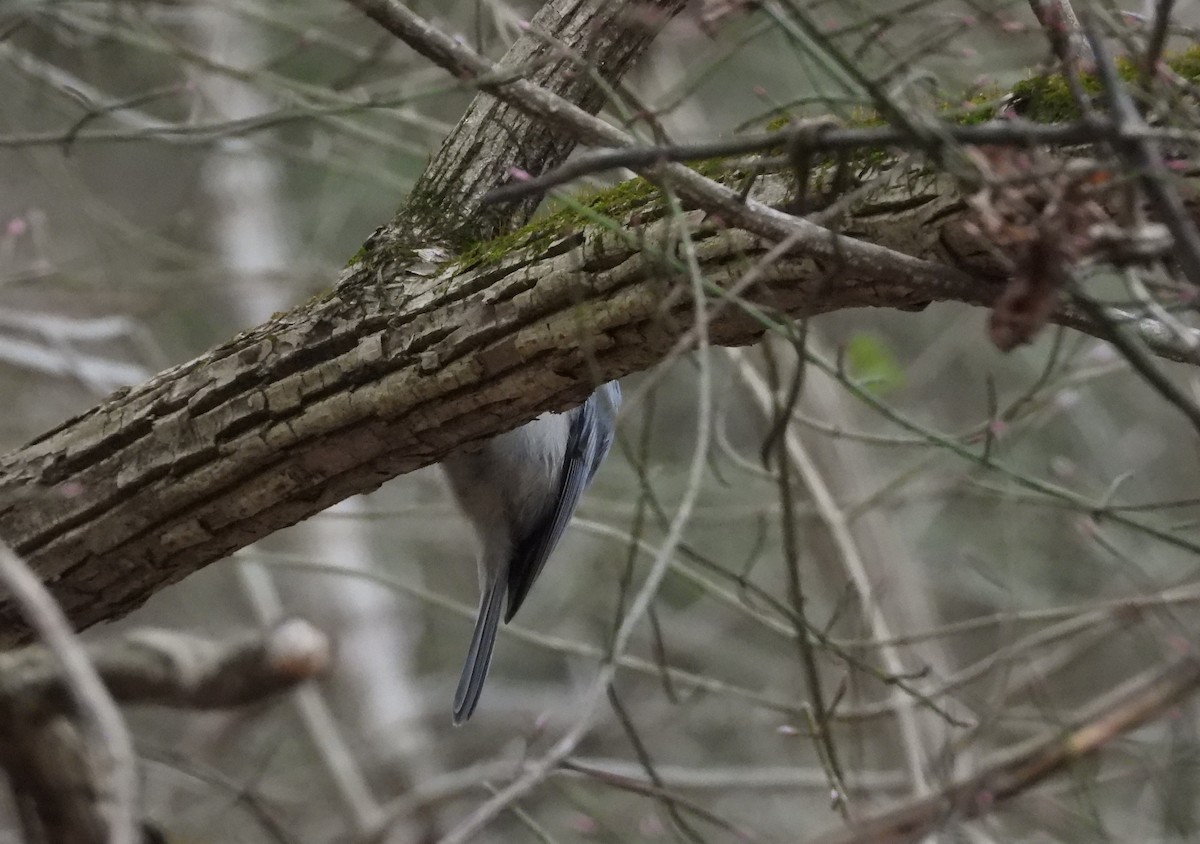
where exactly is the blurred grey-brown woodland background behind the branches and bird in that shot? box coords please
[0,0,1200,844]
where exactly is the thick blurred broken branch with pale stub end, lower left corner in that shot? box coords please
[0,619,329,844]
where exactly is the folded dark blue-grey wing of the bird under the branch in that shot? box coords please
[504,393,599,622]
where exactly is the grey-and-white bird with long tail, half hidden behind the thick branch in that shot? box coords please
[442,381,620,725]
